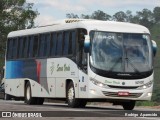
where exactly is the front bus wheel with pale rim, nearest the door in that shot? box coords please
[67,82,80,108]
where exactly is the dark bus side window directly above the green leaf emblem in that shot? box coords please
[50,33,57,56]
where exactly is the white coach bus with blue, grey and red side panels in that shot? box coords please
[5,19,157,110]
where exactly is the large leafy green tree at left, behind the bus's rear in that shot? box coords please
[0,0,38,67]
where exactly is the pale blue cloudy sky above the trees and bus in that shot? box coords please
[26,0,160,26]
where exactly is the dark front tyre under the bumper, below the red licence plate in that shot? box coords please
[122,101,136,110]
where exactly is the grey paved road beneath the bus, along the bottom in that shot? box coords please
[0,100,160,120]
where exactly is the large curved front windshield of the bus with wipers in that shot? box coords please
[90,31,152,73]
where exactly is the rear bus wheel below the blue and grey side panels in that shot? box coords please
[25,82,36,105]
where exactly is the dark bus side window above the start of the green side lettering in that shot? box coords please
[56,32,63,56]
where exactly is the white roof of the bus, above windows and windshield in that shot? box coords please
[8,19,150,38]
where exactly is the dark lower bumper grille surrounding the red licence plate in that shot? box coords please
[102,91,143,98]
